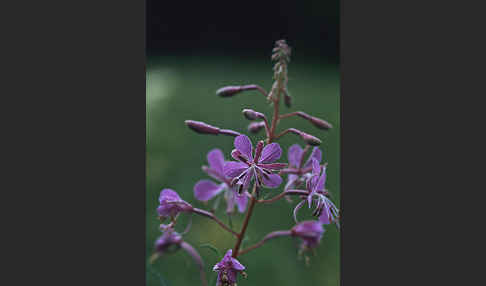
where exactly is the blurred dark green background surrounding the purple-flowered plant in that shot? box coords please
[146,56,340,286]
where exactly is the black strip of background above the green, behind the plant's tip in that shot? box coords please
[146,0,339,62]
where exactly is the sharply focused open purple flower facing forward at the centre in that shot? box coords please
[224,135,287,191]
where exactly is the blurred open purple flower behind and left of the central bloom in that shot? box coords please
[194,149,248,213]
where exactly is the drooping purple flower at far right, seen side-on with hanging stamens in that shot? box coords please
[294,158,339,226]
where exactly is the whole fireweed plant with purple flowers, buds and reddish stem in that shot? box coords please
[151,40,339,286]
